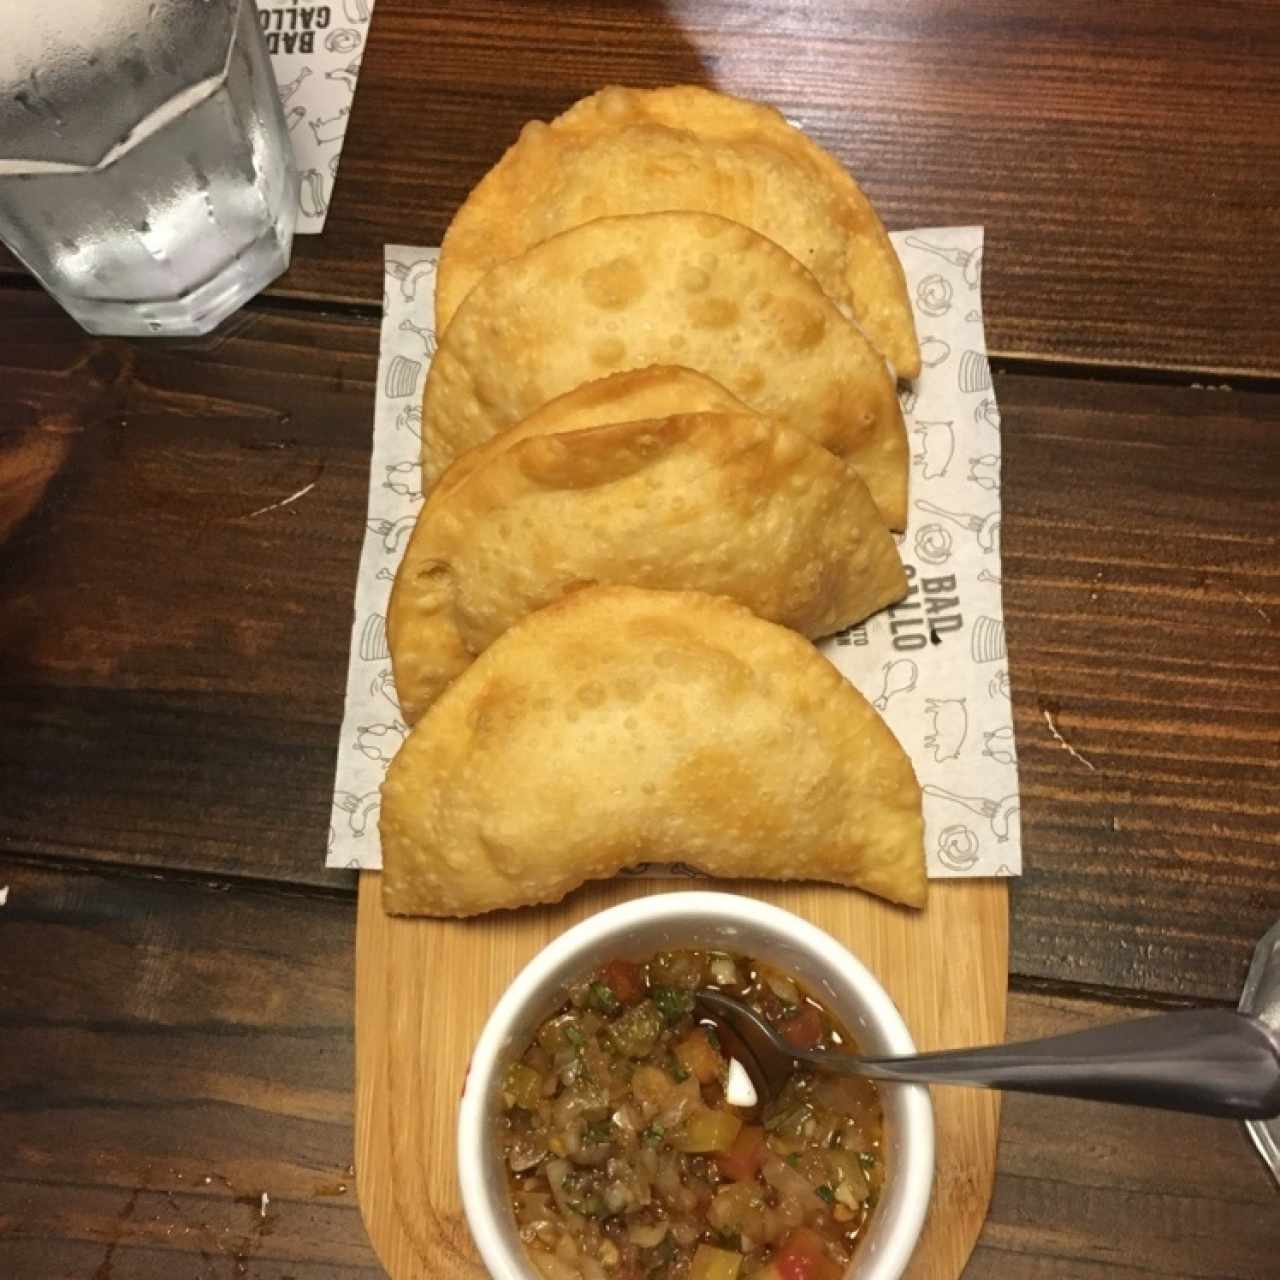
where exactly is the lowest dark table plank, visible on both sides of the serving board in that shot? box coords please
[0,863,1280,1280]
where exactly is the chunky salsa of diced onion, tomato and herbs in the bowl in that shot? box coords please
[499,951,883,1280]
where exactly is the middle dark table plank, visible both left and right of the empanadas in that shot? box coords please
[0,293,1280,1000]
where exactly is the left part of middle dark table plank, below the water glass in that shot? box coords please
[0,293,378,890]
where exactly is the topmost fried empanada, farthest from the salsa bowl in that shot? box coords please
[435,84,920,378]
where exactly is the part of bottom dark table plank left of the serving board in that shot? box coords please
[0,865,381,1280]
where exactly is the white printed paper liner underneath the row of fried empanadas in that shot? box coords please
[326,227,1021,878]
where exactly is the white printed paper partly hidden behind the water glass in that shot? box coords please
[257,0,374,236]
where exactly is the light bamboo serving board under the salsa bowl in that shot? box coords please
[356,872,1009,1280]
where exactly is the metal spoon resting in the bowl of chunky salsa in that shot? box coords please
[696,991,1280,1120]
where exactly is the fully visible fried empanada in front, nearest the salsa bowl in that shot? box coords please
[380,586,925,915]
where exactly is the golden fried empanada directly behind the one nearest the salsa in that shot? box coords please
[387,413,906,723]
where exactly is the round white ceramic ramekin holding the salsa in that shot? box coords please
[458,893,933,1280]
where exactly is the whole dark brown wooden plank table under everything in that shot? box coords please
[0,0,1280,1280]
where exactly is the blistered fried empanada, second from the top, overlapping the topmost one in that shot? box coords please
[422,212,908,529]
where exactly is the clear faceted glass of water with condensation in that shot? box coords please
[0,0,298,335]
